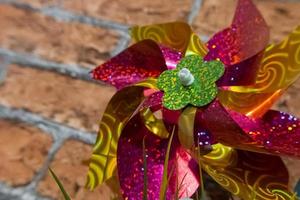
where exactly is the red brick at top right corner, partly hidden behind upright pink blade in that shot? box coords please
[193,0,300,42]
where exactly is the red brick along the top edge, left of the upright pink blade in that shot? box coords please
[22,0,193,25]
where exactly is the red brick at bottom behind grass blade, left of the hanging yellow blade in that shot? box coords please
[38,141,118,200]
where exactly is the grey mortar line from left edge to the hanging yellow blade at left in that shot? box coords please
[0,105,96,145]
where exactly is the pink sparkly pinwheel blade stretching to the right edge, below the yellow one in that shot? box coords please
[199,101,300,157]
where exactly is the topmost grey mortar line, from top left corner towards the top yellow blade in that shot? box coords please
[0,0,128,33]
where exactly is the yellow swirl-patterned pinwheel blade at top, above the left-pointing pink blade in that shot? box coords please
[131,22,192,53]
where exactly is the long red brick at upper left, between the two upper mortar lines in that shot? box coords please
[0,5,118,66]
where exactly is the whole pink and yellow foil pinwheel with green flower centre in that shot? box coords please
[87,0,300,200]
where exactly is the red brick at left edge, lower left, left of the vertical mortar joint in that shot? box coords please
[0,120,52,186]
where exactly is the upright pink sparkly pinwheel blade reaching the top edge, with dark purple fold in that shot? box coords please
[205,0,269,86]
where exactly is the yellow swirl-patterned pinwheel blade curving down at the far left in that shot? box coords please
[86,79,156,189]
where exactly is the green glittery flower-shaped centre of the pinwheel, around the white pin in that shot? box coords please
[157,55,224,110]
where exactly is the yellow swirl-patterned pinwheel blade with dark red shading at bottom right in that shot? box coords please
[200,144,293,200]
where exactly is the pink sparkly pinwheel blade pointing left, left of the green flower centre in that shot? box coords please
[92,40,167,89]
